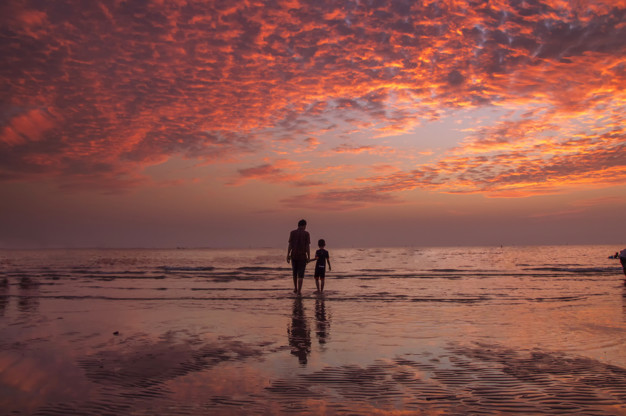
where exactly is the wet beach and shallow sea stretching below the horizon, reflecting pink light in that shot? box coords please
[0,246,626,415]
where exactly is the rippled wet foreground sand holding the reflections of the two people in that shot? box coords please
[0,295,626,415]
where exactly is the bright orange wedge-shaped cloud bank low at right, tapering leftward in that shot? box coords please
[352,134,626,197]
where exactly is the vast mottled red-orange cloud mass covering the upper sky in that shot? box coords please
[0,0,626,202]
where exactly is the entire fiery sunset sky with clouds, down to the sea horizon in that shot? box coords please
[0,0,626,250]
